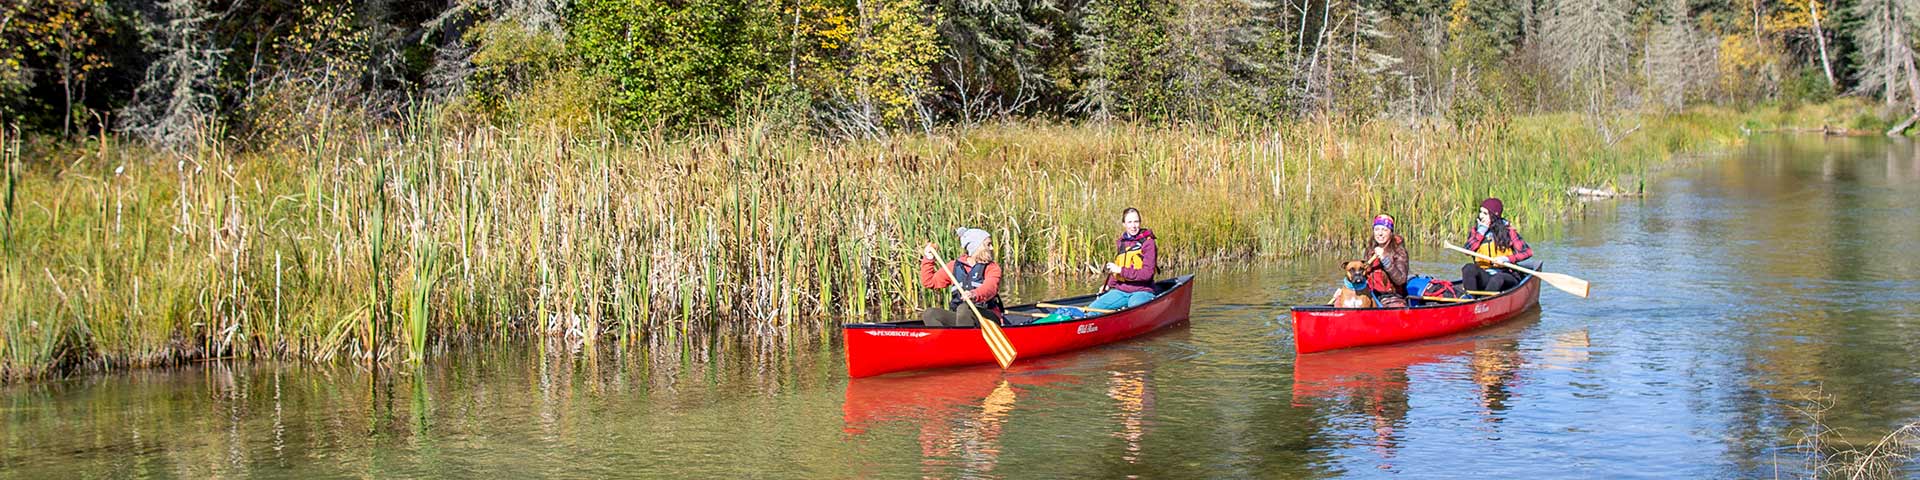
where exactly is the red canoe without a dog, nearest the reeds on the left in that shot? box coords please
[845,275,1194,378]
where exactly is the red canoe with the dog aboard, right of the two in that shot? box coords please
[1294,276,1540,353]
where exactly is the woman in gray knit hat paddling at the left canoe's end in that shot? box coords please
[920,227,1006,326]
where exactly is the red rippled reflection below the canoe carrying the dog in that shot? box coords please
[1294,311,1538,460]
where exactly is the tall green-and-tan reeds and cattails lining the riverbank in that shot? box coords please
[0,102,1873,382]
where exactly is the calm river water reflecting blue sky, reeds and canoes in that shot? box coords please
[0,136,1920,478]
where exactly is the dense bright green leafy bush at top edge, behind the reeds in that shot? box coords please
[566,0,785,127]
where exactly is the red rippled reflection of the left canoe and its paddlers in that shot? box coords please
[843,348,1154,476]
